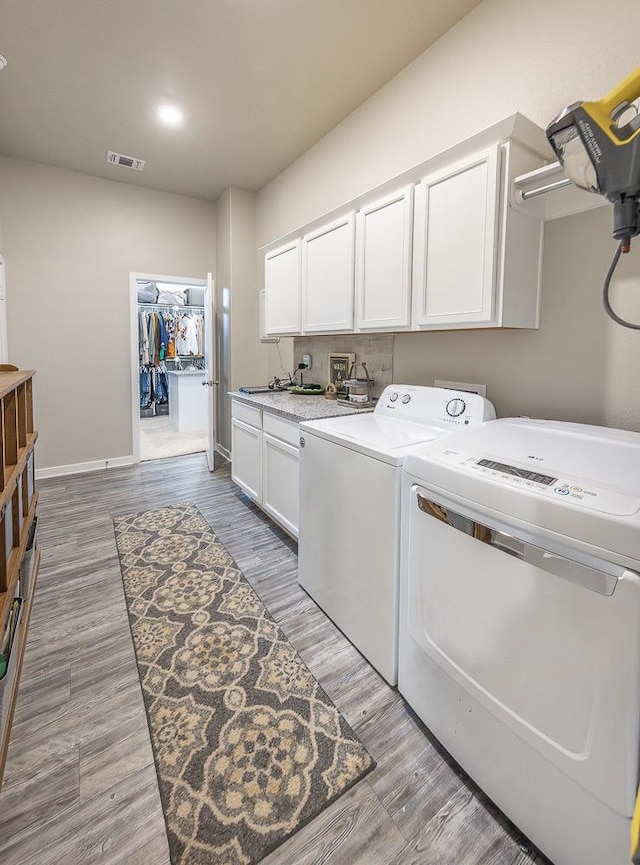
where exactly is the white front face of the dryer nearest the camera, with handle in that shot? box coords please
[399,477,640,865]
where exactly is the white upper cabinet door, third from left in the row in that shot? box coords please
[356,187,413,330]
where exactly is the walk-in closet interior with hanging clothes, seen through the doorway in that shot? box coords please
[136,279,207,460]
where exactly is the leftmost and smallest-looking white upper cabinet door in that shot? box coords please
[264,240,301,336]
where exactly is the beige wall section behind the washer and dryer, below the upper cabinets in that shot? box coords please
[394,207,640,430]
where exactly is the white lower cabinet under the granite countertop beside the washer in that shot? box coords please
[231,400,299,538]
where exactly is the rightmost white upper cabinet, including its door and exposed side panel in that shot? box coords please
[412,142,542,329]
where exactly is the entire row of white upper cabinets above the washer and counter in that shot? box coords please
[265,114,548,337]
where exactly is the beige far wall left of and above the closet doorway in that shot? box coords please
[0,156,215,468]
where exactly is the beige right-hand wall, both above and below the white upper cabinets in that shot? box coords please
[257,0,640,430]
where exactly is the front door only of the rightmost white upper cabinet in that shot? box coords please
[413,145,500,328]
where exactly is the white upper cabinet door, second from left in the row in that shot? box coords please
[302,213,355,333]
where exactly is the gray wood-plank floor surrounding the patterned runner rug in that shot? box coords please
[0,454,544,865]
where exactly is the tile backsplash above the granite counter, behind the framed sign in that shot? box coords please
[293,333,393,396]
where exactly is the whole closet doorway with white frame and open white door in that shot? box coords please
[130,273,215,467]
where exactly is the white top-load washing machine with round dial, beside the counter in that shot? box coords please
[298,384,495,685]
